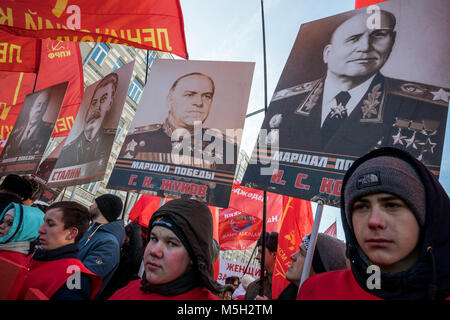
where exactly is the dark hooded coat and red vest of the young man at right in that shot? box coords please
[299,148,450,300]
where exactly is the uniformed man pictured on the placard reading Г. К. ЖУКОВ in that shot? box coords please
[119,72,238,171]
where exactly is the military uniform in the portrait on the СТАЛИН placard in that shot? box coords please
[57,129,116,168]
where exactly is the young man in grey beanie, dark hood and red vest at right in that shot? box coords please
[298,148,450,300]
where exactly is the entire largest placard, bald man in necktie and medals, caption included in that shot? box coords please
[242,0,450,205]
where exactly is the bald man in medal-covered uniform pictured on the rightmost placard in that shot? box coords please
[262,10,449,165]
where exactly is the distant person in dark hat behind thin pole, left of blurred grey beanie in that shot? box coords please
[244,232,278,300]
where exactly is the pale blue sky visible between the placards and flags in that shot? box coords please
[180,0,450,239]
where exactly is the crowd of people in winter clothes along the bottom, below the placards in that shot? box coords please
[0,147,450,300]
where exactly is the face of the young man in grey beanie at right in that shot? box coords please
[352,193,420,273]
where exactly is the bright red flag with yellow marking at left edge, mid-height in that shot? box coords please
[0,71,36,153]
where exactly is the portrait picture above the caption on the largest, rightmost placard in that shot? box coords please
[262,0,450,166]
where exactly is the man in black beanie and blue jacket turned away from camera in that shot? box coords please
[79,194,125,299]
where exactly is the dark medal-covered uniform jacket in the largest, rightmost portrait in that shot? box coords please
[262,73,450,165]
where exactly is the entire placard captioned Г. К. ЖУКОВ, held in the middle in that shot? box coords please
[108,60,254,208]
